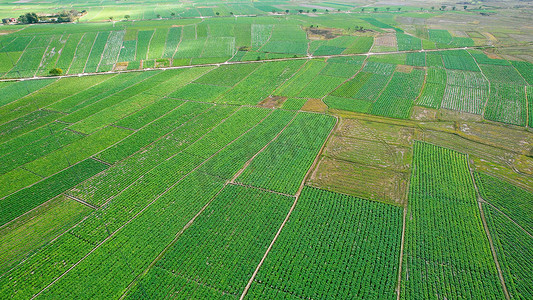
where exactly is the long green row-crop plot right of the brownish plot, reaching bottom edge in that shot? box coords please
[401,142,504,299]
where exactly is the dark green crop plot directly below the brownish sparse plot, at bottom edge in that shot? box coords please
[246,187,402,299]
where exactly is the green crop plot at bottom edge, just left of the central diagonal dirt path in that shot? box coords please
[123,185,293,299]
